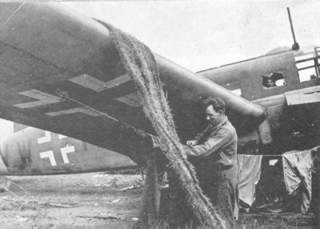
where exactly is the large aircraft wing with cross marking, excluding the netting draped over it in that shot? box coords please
[0,3,264,163]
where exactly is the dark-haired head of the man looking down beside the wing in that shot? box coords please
[203,97,225,125]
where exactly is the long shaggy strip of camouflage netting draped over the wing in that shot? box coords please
[108,25,225,228]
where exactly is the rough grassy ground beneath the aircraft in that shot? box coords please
[0,173,317,229]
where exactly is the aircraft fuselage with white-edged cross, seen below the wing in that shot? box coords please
[0,123,137,175]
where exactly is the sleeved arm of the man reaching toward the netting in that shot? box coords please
[186,129,233,157]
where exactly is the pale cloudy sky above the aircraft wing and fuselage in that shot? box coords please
[0,0,320,135]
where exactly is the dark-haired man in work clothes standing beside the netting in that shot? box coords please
[186,98,238,228]
